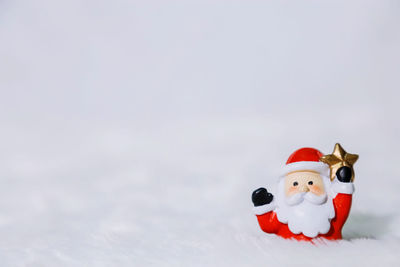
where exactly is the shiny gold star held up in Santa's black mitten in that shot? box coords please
[319,143,358,181]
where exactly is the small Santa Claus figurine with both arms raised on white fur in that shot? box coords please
[252,147,358,241]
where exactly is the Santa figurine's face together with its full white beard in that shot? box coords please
[276,171,335,237]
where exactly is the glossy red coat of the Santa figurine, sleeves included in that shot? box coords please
[257,193,352,241]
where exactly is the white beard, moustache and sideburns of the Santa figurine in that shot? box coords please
[276,177,335,237]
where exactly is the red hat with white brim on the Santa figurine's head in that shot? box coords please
[282,147,329,176]
